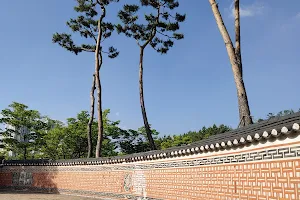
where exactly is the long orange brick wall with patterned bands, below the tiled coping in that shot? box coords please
[0,134,300,200]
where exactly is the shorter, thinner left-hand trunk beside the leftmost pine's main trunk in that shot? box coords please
[87,74,96,158]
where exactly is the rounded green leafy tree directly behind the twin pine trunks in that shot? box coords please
[43,109,121,159]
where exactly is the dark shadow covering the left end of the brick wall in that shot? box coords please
[0,160,59,194]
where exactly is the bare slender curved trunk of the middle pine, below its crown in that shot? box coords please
[139,47,156,150]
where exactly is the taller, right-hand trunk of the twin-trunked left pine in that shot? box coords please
[95,1,106,158]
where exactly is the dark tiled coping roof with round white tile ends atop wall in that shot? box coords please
[4,112,300,166]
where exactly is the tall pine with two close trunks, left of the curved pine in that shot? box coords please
[52,0,119,157]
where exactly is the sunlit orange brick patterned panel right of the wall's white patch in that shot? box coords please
[141,160,300,200]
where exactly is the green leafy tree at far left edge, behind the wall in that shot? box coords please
[0,102,48,159]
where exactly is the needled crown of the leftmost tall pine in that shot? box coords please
[52,0,119,58]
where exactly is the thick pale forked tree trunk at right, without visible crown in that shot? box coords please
[209,0,253,126]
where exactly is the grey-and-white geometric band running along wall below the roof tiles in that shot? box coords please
[2,145,300,172]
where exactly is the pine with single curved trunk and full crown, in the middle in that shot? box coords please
[117,0,185,150]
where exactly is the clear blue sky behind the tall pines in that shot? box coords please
[0,0,300,134]
